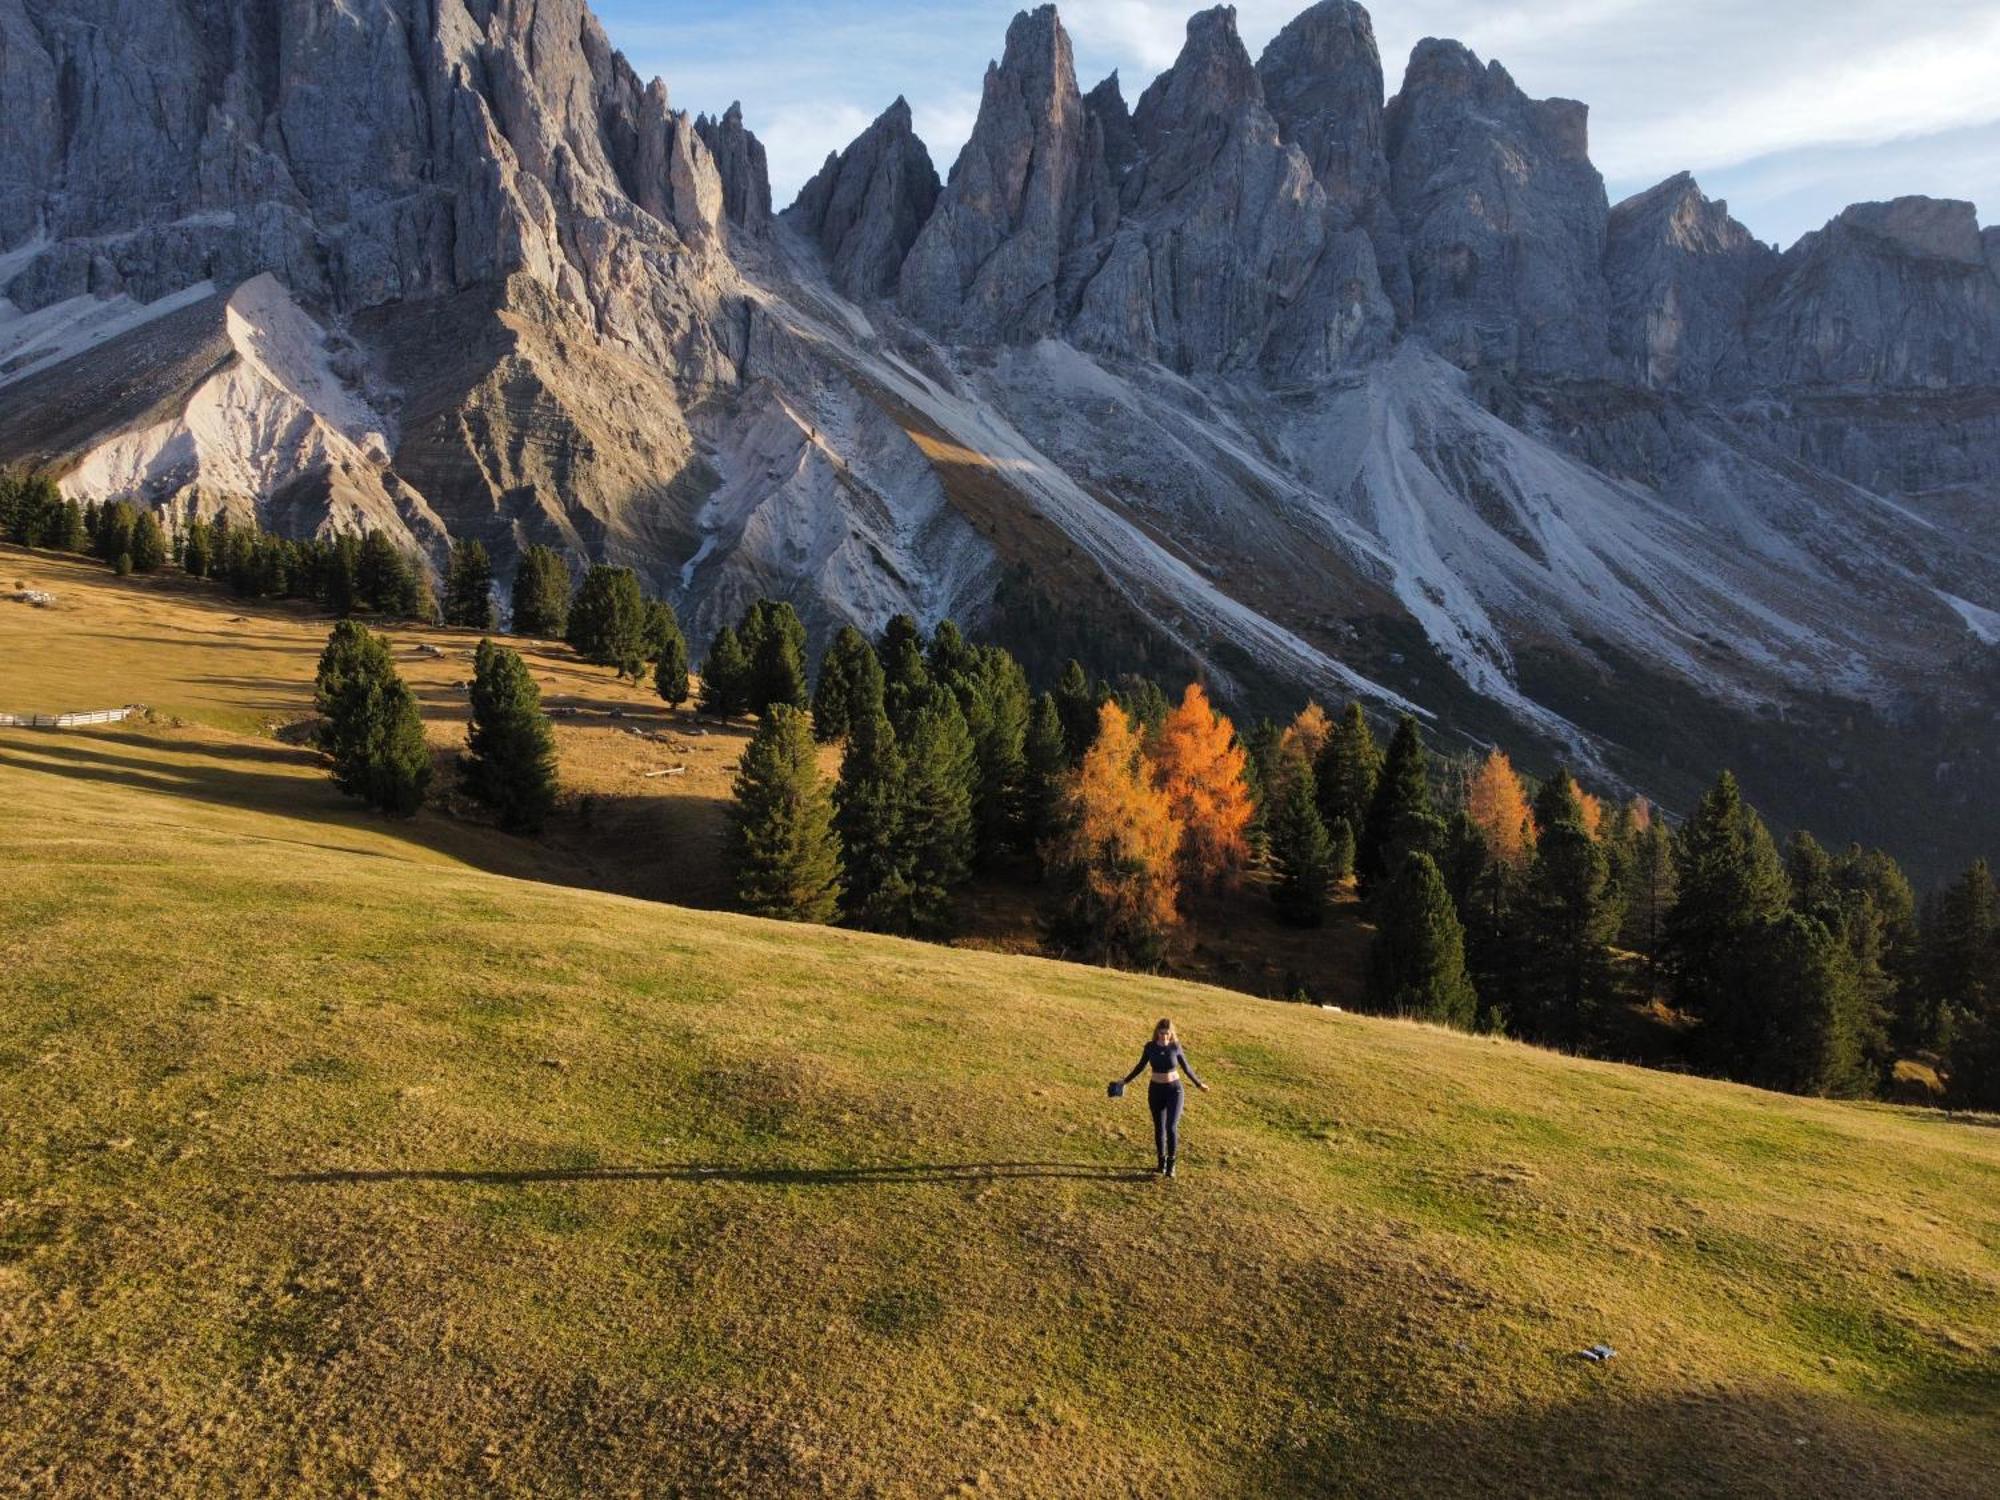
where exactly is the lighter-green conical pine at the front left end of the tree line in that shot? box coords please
[730,704,840,922]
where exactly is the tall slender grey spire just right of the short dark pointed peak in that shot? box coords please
[898,6,1088,342]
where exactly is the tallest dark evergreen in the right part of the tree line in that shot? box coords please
[1666,772,1790,1074]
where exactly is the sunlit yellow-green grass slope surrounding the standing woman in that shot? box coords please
[0,712,2000,1500]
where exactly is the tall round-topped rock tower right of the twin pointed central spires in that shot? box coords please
[1256,0,1410,318]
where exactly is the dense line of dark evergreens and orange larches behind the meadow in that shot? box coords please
[720,602,2000,1106]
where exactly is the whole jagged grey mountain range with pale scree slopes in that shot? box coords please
[0,0,2000,876]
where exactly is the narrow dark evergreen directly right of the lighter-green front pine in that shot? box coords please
[834,650,910,932]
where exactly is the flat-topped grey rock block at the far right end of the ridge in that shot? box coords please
[1750,198,2000,388]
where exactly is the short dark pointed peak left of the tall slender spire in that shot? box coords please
[784,98,938,300]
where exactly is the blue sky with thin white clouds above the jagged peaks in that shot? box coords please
[594,0,2000,244]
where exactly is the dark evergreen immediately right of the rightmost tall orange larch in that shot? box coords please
[1512,812,1618,1044]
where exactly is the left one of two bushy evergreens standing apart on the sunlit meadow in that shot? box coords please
[314,620,430,818]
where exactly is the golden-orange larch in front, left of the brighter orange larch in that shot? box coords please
[1042,702,1180,966]
